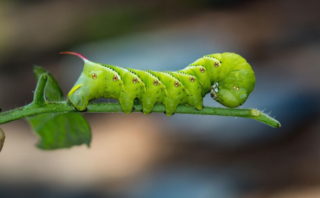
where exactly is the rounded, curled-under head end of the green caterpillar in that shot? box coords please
[206,53,256,108]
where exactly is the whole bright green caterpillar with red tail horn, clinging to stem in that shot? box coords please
[60,52,255,116]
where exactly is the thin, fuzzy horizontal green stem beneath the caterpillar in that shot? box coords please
[0,101,281,127]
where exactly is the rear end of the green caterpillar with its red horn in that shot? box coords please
[60,52,110,111]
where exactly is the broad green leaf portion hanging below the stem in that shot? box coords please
[27,113,91,150]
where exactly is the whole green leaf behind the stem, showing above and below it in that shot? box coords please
[27,66,91,150]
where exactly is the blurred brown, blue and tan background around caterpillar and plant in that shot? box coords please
[0,0,320,198]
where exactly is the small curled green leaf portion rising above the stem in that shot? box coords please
[33,66,64,101]
